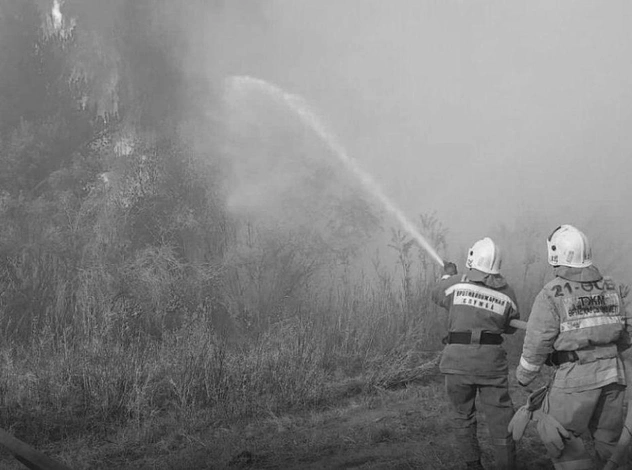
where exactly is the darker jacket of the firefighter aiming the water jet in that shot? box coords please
[432,269,520,377]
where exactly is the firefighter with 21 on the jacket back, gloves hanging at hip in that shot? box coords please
[516,225,632,470]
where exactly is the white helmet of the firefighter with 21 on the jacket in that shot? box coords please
[546,225,592,268]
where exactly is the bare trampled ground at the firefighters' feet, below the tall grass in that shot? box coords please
[0,374,568,470]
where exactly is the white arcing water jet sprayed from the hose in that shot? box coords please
[227,76,443,266]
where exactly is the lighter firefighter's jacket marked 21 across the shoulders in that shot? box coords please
[516,266,632,392]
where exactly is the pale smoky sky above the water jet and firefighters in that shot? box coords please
[206,0,632,276]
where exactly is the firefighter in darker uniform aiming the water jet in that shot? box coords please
[433,238,519,469]
